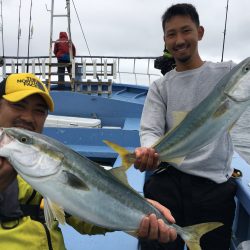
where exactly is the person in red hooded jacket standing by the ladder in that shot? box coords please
[54,32,76,86]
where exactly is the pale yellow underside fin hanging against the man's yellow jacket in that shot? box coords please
[44,198,65,229]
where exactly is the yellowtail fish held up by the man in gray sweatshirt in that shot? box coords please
[104,57,250,167]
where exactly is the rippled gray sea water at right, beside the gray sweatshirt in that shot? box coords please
[231,107,250,164]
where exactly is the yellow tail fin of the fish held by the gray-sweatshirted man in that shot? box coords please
[103,140,135,170]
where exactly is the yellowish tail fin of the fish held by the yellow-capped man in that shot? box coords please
[181,222,223,250]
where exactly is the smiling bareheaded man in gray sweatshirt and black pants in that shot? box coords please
[135,3,237,250]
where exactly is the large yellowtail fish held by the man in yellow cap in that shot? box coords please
[0,128,222,250]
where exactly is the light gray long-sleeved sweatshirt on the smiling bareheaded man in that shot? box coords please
[140,61,235,183]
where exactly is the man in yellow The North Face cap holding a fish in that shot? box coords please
[0,73,176,250]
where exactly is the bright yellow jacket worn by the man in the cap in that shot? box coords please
[0,176,107,250]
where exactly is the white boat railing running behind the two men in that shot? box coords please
[0,56,161,86]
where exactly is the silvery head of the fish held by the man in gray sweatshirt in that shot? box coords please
[224,57,250,102]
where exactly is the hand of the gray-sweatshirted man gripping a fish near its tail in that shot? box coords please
[134,147,159,172]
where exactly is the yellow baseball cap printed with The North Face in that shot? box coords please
[0,73,54,112]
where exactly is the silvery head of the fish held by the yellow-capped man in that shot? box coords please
[0,128,64,179]
